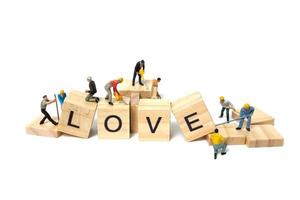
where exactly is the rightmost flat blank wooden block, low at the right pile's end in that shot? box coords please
[259,125,284,147]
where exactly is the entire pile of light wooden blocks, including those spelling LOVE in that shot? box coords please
[26,80,283,147]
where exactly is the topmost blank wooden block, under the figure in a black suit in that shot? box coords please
[118,80,153,98]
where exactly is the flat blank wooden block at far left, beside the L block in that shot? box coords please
[26,116,61,138]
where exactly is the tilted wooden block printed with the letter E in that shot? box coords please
[172,92,215,141]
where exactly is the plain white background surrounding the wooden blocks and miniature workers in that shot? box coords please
[0,0,300,200]
